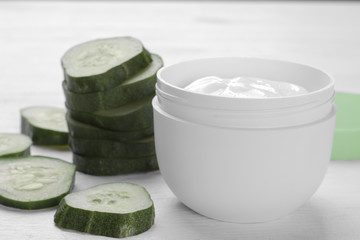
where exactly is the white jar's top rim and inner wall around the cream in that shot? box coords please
[157,57,335,110]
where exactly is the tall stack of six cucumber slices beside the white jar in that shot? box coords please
[61,37,163,175]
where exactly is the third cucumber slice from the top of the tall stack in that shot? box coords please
[67,94,155,131]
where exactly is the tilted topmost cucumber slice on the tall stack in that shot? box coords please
[61,37,152,93]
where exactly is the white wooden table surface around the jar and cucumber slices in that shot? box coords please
[0,1,360,240]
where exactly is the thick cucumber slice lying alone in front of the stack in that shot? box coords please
[54,183,155,238]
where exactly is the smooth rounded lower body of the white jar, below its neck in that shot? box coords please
[153,99,336,223]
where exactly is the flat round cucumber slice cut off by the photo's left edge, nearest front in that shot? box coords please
[0,156,75,209]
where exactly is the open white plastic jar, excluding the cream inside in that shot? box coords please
[153,58,336,223]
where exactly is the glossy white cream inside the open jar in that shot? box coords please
[185,76,308,98]
